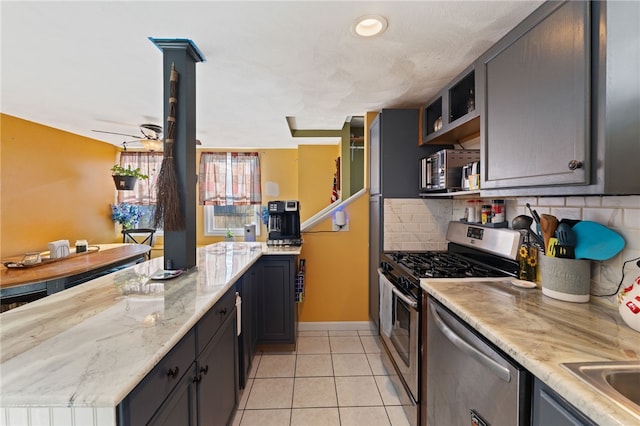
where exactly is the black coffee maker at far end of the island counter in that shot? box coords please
[267,200,302,246]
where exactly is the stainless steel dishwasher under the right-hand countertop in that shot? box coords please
[423,297,531,426]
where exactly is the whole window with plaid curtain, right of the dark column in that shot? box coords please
[199,152,262,235]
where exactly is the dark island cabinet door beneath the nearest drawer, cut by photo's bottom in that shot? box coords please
[148,364,197,426]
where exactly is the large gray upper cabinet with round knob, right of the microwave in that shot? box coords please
[475,1,640,195]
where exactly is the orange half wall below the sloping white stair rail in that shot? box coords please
[299,194,369,322]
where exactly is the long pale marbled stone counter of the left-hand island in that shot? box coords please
[0,243,290,426]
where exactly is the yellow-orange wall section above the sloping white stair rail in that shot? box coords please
[298,145,340,222]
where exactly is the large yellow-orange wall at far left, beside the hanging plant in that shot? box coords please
[0,114,120,258]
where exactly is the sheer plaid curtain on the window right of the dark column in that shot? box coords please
[199,152,262,206]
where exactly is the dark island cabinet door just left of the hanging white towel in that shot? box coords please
[196,308,238,426]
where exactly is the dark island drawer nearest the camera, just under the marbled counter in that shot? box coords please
[120,330,196,425]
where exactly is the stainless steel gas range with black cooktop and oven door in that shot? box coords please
[378,222,522,425]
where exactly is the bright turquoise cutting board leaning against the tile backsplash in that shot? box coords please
[573,220,625,260]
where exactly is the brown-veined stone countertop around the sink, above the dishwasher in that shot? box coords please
[421,279,640,425]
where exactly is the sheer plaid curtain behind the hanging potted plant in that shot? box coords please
[118,152,164,205]
